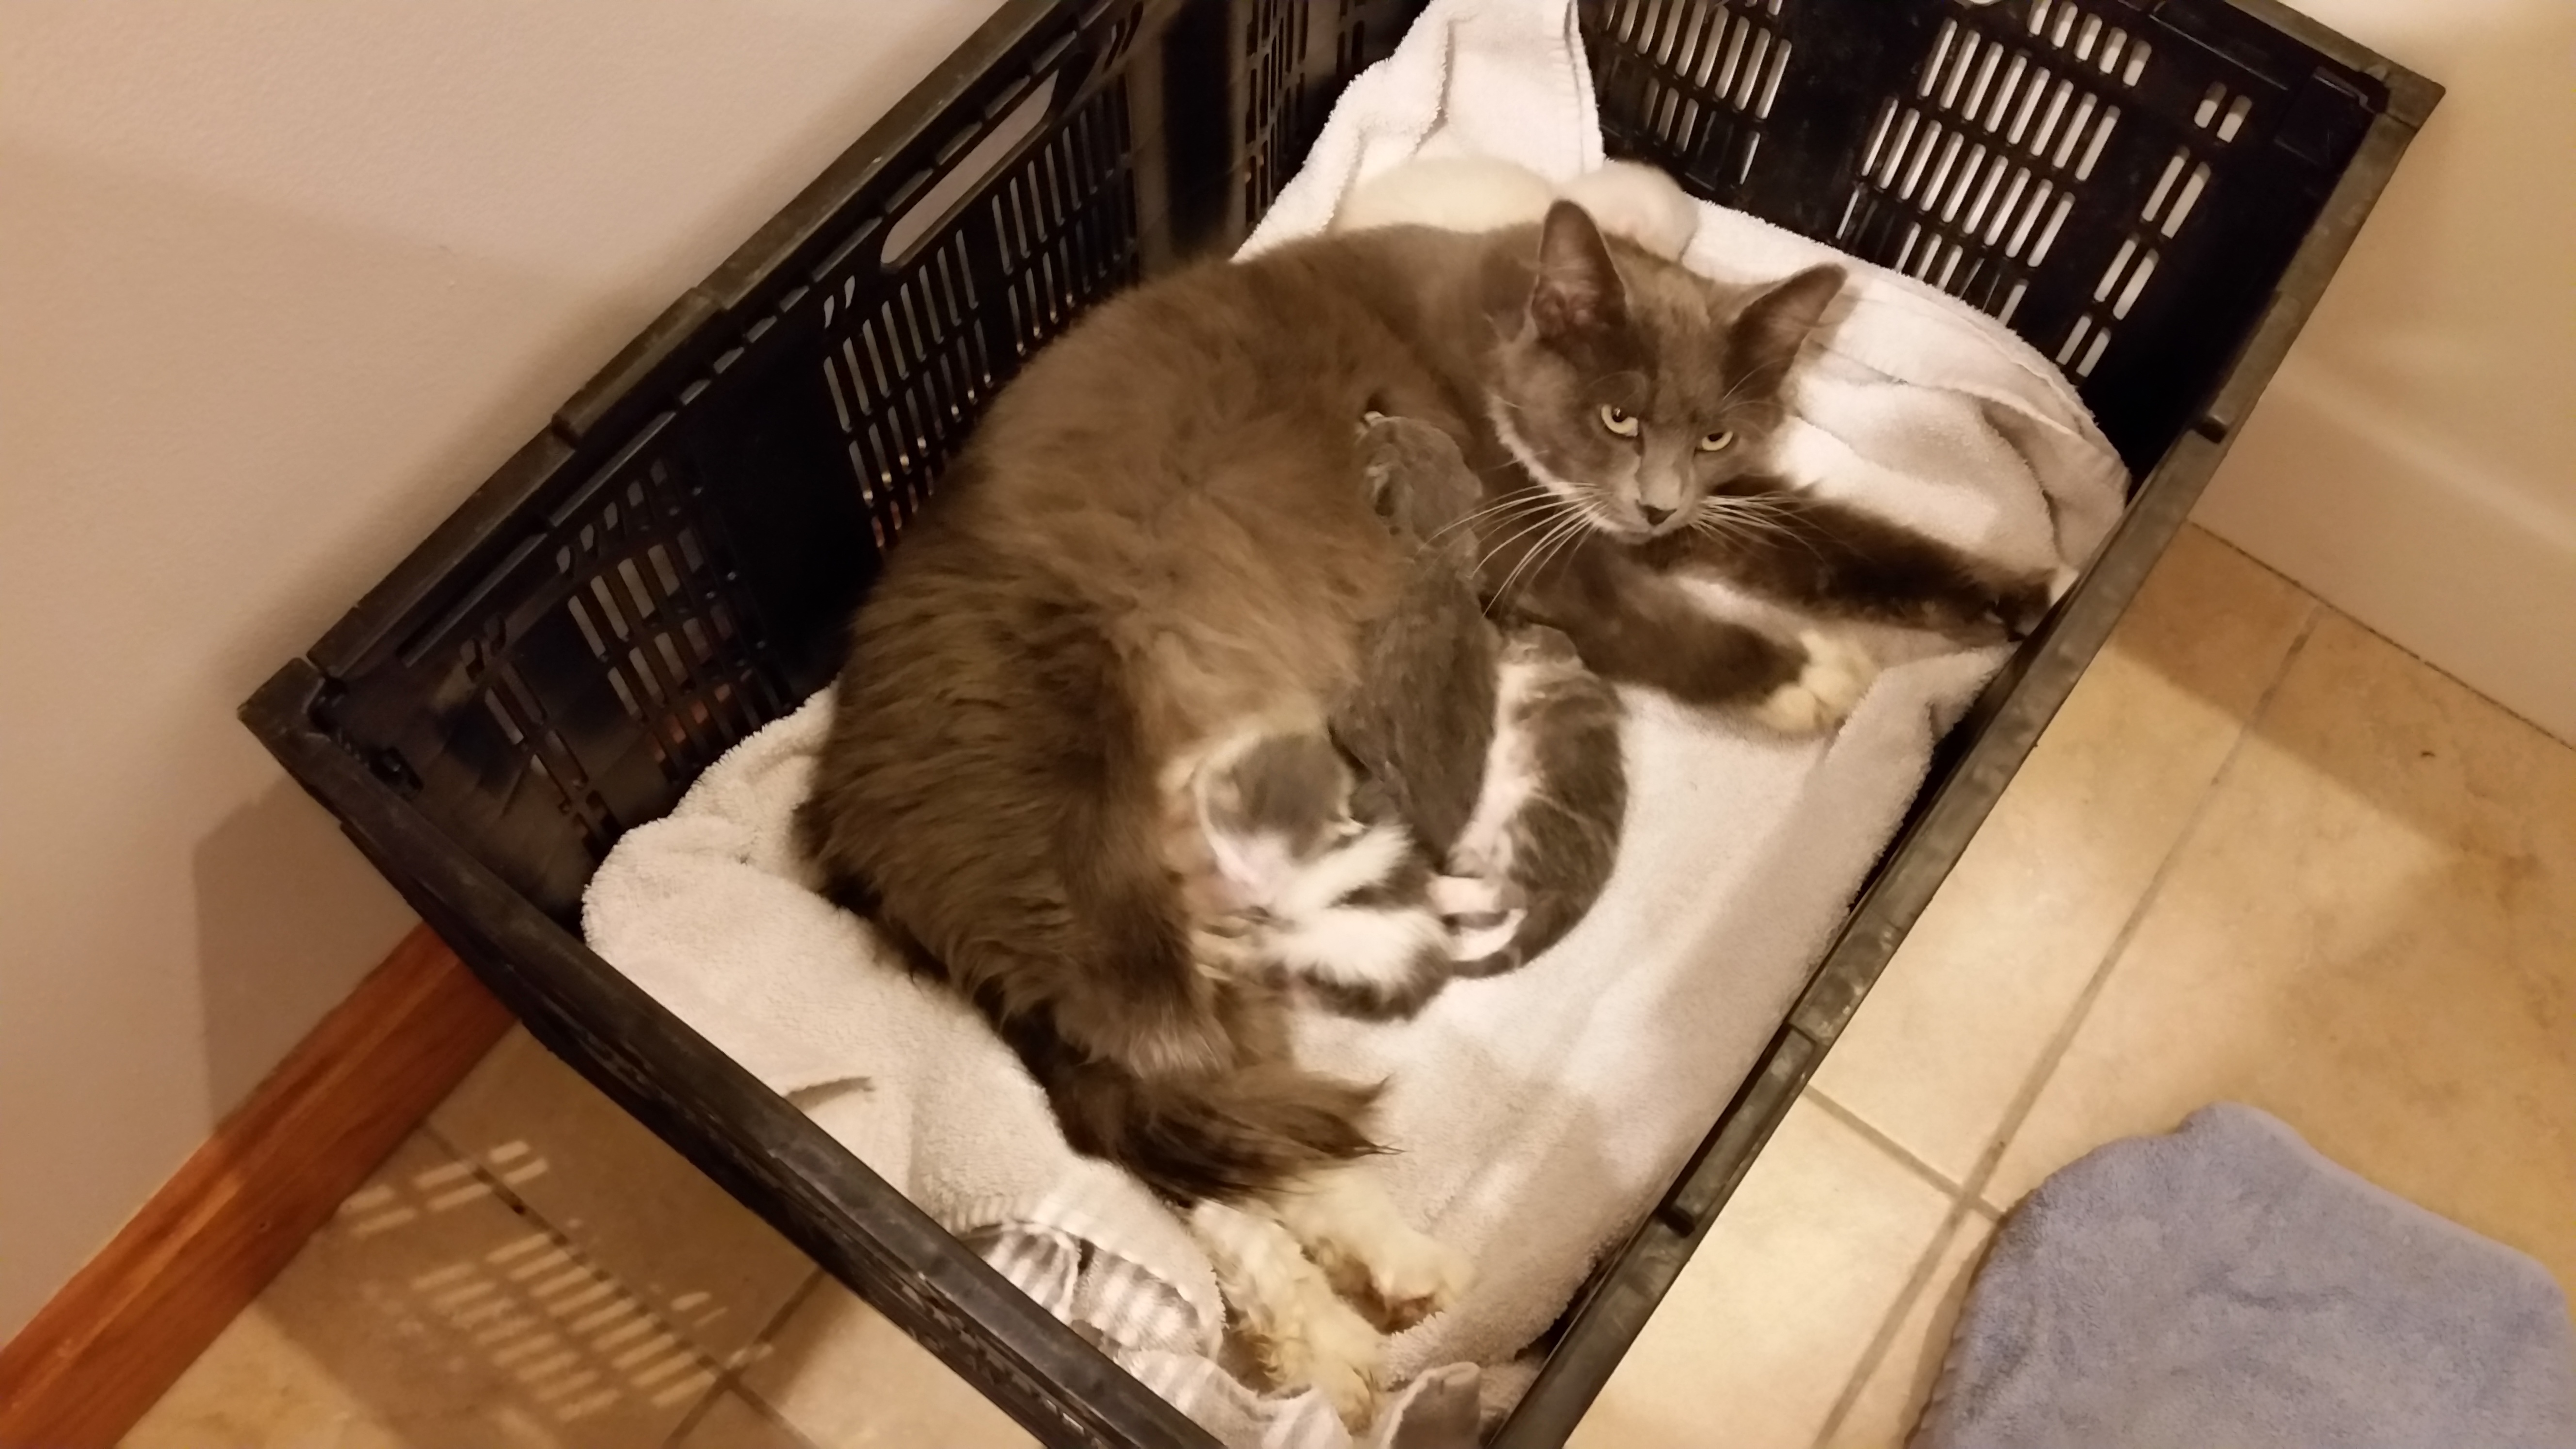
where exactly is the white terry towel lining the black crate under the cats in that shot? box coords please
[585,0,2125,1449]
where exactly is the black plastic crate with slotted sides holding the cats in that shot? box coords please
[242,0,2439,1447]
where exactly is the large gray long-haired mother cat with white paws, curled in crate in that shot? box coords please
[804,189,2043,1418]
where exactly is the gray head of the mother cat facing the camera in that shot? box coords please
[1492,201,1844,539]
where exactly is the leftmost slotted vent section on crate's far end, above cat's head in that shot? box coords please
[1600,0,1793,186]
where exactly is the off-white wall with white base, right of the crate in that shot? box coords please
[2197,0,2576,742]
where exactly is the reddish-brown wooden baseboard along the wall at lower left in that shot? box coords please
[0,926,510,1449]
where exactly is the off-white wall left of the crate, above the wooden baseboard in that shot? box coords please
[0,0,994,1338]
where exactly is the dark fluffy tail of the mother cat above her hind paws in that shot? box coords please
[1002,1000,1381,1204]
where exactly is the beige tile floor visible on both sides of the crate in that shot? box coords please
[126,531,2576,1449]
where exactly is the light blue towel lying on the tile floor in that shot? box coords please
[1912,1104,2576,1449]
